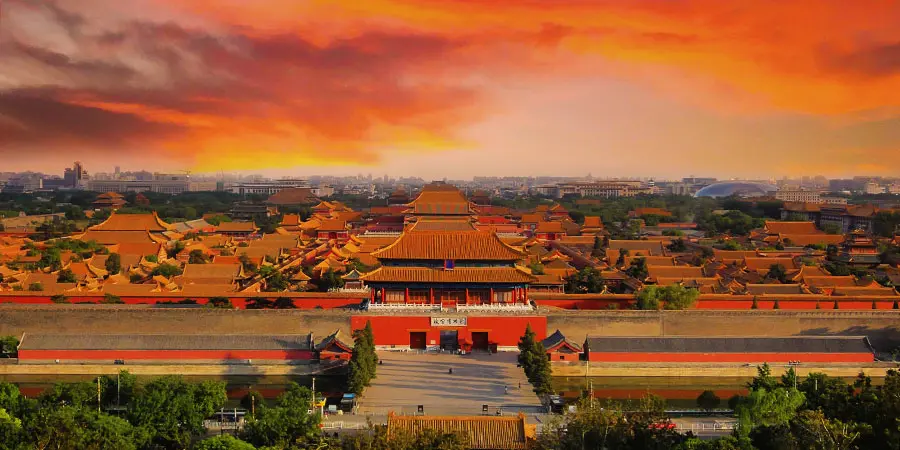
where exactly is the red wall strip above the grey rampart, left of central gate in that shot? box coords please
[0,292,363,309]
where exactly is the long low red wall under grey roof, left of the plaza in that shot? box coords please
[19,350,313,361]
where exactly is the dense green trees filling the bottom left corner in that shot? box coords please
[0,371,226,450]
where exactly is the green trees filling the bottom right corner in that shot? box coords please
[535,365,900,450]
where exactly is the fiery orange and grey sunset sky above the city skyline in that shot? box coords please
[0,0,900,179]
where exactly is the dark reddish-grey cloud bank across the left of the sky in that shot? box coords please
[0,0,486,153]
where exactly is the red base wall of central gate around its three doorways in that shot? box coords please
[350,314,547,348]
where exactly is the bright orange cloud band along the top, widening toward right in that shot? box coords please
[174,0,900,114]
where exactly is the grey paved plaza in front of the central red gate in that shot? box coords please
[359,352,541,415]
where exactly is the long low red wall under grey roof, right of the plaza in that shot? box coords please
[588,352,875,363]
